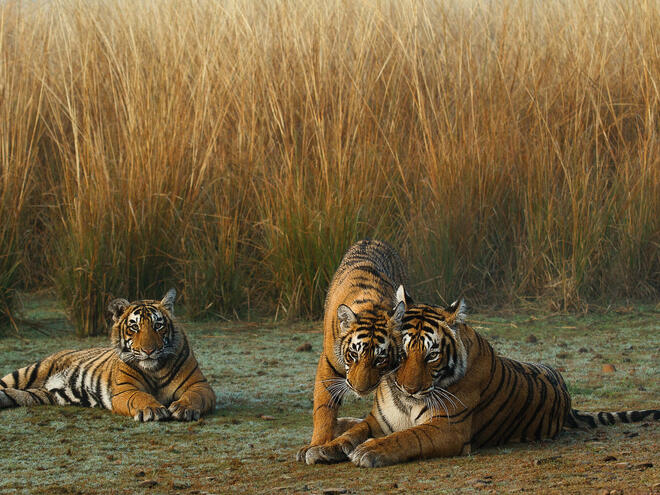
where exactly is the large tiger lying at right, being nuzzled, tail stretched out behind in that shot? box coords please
[307,300,660,467]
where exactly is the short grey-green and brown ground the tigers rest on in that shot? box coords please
[0,297,660,494]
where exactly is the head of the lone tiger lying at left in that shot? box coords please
[108,289,181,371]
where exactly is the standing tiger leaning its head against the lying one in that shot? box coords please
[297,240,408,463]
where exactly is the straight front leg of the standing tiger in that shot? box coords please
[296,353,346,462]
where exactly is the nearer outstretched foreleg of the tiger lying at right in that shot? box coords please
[349,418,472,467]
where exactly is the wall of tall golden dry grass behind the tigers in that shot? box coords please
[0,0,660,334]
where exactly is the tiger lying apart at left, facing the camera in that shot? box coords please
[0,289,215,422]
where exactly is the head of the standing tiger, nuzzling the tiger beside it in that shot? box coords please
[335,286,406,396]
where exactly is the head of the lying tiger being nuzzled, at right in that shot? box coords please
[395,300,467,406]
